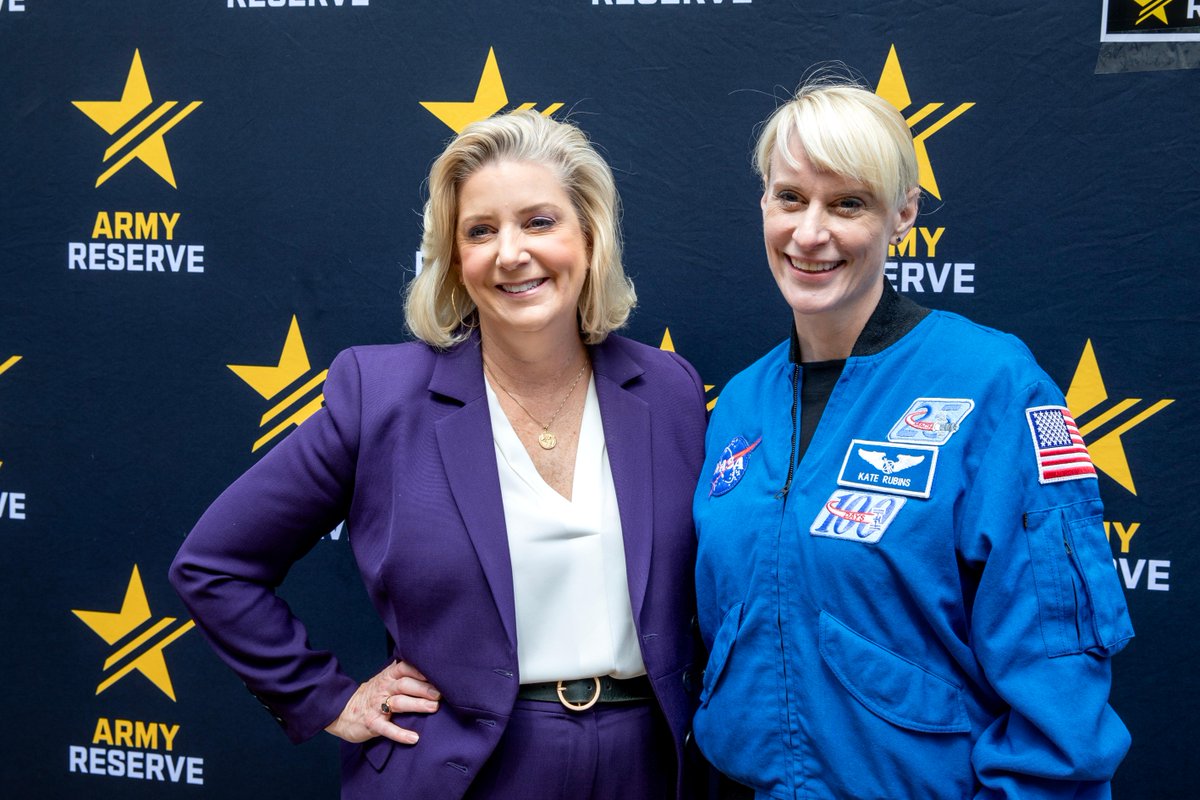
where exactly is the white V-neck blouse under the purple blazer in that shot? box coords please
[484,378,646,684]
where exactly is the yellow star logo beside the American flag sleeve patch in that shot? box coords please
[1067,339,1175,494]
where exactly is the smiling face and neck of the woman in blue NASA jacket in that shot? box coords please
[762,140,918,361]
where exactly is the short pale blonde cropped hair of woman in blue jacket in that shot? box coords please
[755,76,919,210]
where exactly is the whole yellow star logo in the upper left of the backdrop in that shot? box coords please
[72,50,200,188]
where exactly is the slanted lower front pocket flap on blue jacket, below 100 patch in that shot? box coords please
[820,612,971,733]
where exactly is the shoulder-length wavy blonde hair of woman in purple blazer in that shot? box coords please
[404,110,637,348]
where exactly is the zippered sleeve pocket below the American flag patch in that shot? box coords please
[1025,500,1133,658]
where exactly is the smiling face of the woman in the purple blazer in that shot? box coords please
[455,161,588,341]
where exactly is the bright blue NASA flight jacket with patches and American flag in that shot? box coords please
[694,288,1133,800]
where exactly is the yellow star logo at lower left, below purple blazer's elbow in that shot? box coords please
[71,564,196,700]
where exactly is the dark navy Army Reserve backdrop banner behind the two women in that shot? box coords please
[0,0,1200,798]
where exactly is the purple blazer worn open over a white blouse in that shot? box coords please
[170,336,704,800]
